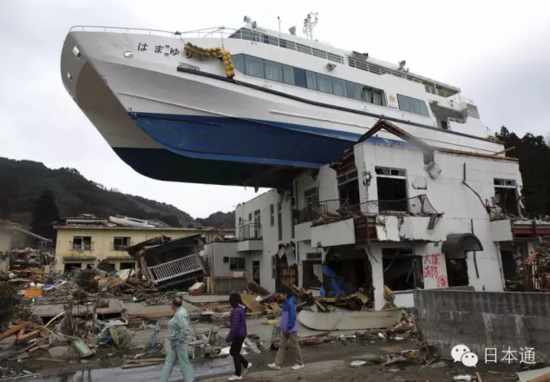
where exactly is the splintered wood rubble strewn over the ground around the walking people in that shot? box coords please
[0,246,422,377]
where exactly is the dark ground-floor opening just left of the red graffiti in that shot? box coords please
[382,248,424,291]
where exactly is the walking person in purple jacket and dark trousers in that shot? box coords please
[226,293,252,381]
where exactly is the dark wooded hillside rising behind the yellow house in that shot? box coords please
[0,157,234,228]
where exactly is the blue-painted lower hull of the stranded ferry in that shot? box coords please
[122,113,414,188]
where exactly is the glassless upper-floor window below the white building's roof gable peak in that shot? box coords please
[375,167,409,213]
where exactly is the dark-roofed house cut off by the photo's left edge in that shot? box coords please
[0,220,53,272]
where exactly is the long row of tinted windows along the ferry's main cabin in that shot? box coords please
[232,54,388,106]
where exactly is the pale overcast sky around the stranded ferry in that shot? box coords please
[0,0,550,217]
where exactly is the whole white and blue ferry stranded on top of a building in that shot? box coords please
[61,18,502,187]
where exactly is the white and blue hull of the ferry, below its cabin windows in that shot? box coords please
[61,26,502,186]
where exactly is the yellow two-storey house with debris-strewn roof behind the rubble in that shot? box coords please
[55,215,235,272]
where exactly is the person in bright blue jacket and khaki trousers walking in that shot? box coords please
[267,290,304,370]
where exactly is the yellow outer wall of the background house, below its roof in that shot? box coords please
[55,228,209,272]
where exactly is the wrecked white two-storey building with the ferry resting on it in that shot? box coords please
[205,120,550,309]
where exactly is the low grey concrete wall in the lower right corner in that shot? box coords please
[414,289,550,362]
